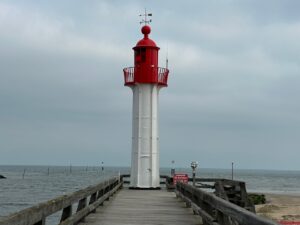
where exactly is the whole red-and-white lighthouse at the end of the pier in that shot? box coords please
[123,15,169,189]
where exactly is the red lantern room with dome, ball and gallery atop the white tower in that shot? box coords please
[123,25,169,86]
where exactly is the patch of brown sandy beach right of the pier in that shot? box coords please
[255,194,300,224]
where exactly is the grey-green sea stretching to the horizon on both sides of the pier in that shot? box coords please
[0,165,300,225]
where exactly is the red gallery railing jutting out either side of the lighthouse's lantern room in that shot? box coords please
[123,67,169,86]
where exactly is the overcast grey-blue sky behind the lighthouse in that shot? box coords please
[0,0,300,170]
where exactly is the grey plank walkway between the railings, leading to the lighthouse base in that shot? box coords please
[83,188,202,225]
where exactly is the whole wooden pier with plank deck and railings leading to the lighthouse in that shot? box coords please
[0,175,278,225]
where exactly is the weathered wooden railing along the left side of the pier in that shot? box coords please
[0,176,123,225]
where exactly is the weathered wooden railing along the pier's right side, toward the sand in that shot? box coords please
[175,182,278,225]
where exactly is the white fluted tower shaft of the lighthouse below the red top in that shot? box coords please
[130,83,160,188]
